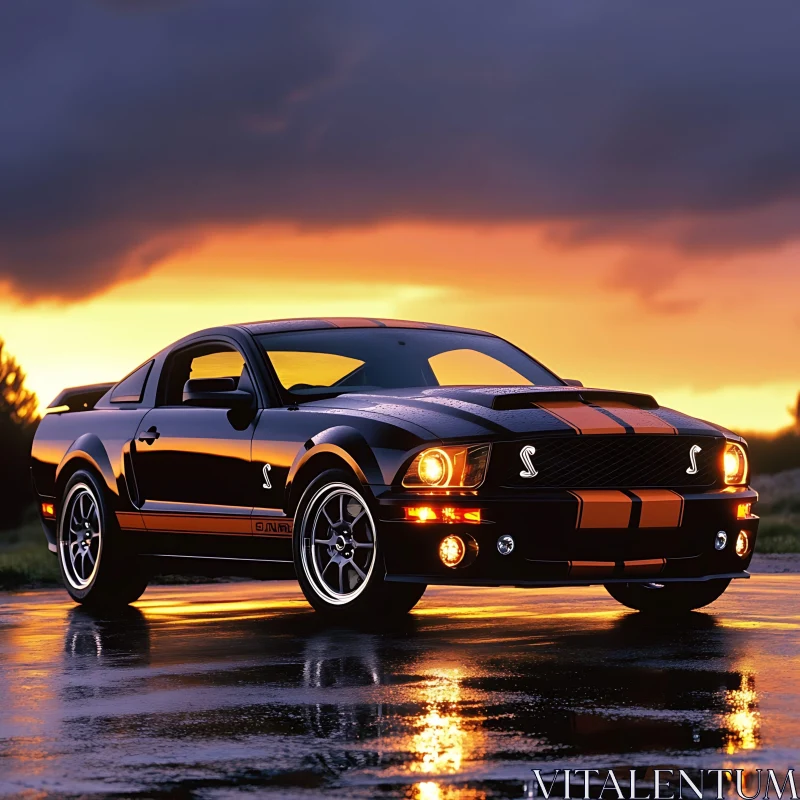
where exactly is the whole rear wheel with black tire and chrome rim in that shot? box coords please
[56,470,148,610]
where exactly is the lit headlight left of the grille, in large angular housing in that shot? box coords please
[403,444,489,489]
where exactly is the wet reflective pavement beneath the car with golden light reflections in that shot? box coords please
[0,575,800,800]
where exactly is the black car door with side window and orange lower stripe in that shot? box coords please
[133,341,258,535]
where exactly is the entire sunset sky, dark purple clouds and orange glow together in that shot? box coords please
[0,0,800,431]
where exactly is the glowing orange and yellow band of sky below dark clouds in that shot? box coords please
[0,224,800,429]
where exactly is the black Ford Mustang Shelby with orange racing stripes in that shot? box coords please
[32,319,758,616]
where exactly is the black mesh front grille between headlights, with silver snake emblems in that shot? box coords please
[488,434,725,489]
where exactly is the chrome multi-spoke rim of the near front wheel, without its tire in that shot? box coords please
[301,483,377,605]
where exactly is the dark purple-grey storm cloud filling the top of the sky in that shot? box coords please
[0,0,800,296]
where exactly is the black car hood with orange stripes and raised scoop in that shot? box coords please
[302,386,738,440]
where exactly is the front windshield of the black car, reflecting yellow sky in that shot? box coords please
[258,328,563,401]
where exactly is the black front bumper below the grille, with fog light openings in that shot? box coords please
[378,488,758,586]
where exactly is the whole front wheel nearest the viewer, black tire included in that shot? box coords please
[293,469,427,621]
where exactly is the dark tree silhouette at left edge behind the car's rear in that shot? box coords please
[0,339,39,528]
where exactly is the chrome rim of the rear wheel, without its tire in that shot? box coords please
[58,483,103,590]
